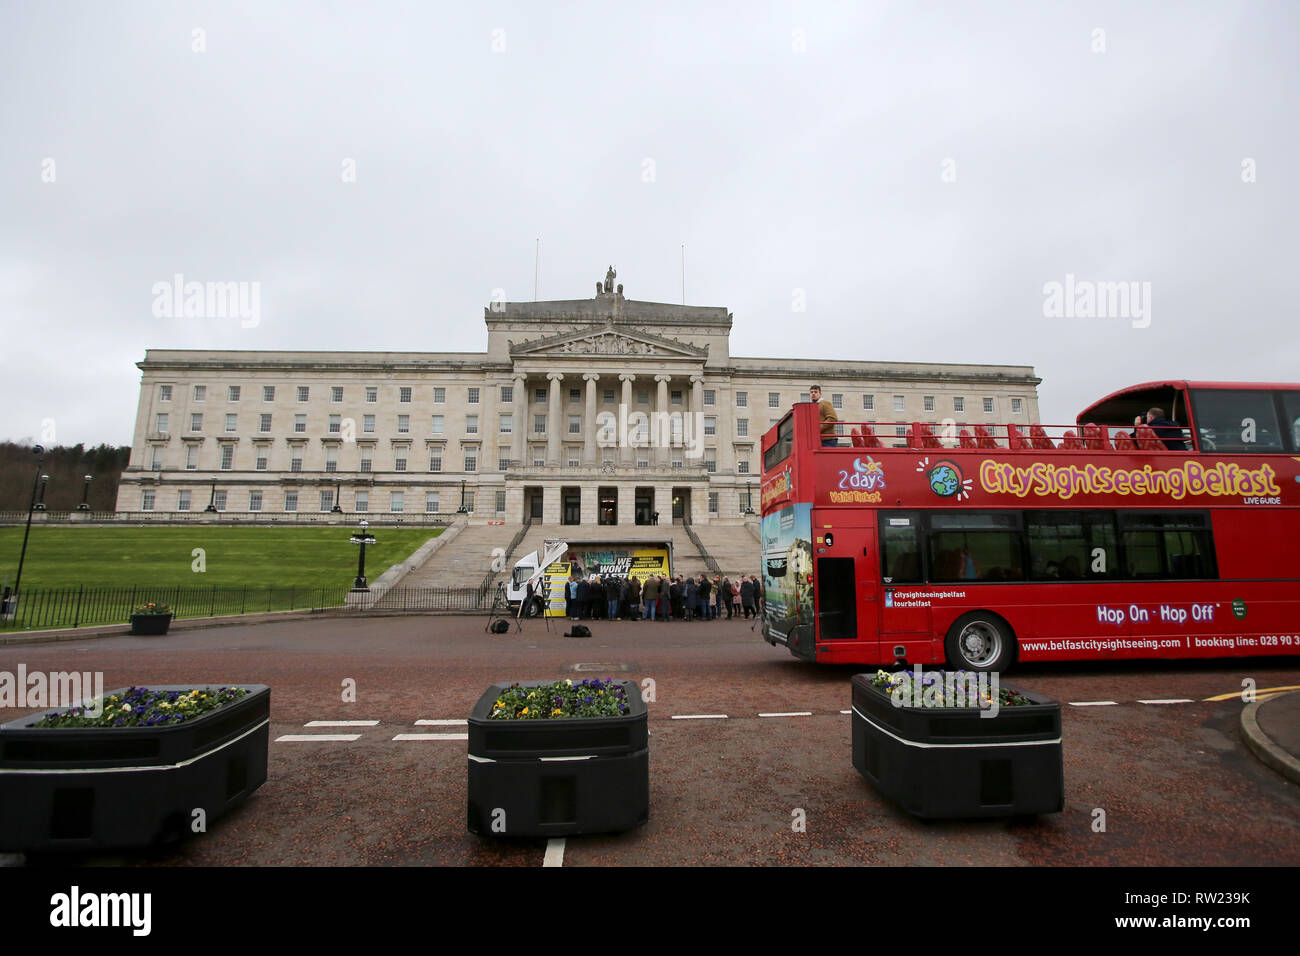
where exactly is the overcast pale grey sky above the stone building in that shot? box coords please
[0,0,1300,444]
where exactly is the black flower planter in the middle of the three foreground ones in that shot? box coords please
[467,680,650,836]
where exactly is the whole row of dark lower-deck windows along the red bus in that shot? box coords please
[880,511,1218,584]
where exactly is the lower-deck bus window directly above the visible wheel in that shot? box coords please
[930,511,1024,583]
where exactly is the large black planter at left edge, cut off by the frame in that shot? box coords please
[0,684,270,852]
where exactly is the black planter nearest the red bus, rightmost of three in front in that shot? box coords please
[853,674,1065,819]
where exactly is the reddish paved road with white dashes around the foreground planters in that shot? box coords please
[0,617,1300,866]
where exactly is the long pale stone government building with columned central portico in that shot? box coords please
[117,267,1040,525]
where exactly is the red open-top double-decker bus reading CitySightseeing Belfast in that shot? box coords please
[762,381,1300,671]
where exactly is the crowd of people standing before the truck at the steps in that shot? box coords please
[564,575,764,620]
